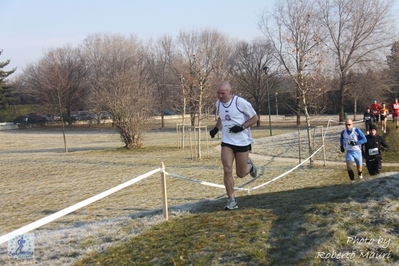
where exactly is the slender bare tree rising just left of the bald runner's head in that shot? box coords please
[172,30,230,128]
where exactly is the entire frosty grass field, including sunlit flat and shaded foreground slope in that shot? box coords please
[0,116,399,265]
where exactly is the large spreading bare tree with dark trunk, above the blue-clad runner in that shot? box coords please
[317,0,394,121]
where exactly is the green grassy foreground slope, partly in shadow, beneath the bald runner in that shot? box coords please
[75,123,399,265]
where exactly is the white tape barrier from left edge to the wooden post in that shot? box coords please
[0,168,161,244]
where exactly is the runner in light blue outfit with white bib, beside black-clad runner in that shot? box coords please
[340,119,367,182]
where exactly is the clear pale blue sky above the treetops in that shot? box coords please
[0,0,274,75]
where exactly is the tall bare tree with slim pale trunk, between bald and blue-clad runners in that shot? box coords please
[260,0,323,165]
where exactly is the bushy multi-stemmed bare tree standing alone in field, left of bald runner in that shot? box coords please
[83,34,153,149]
